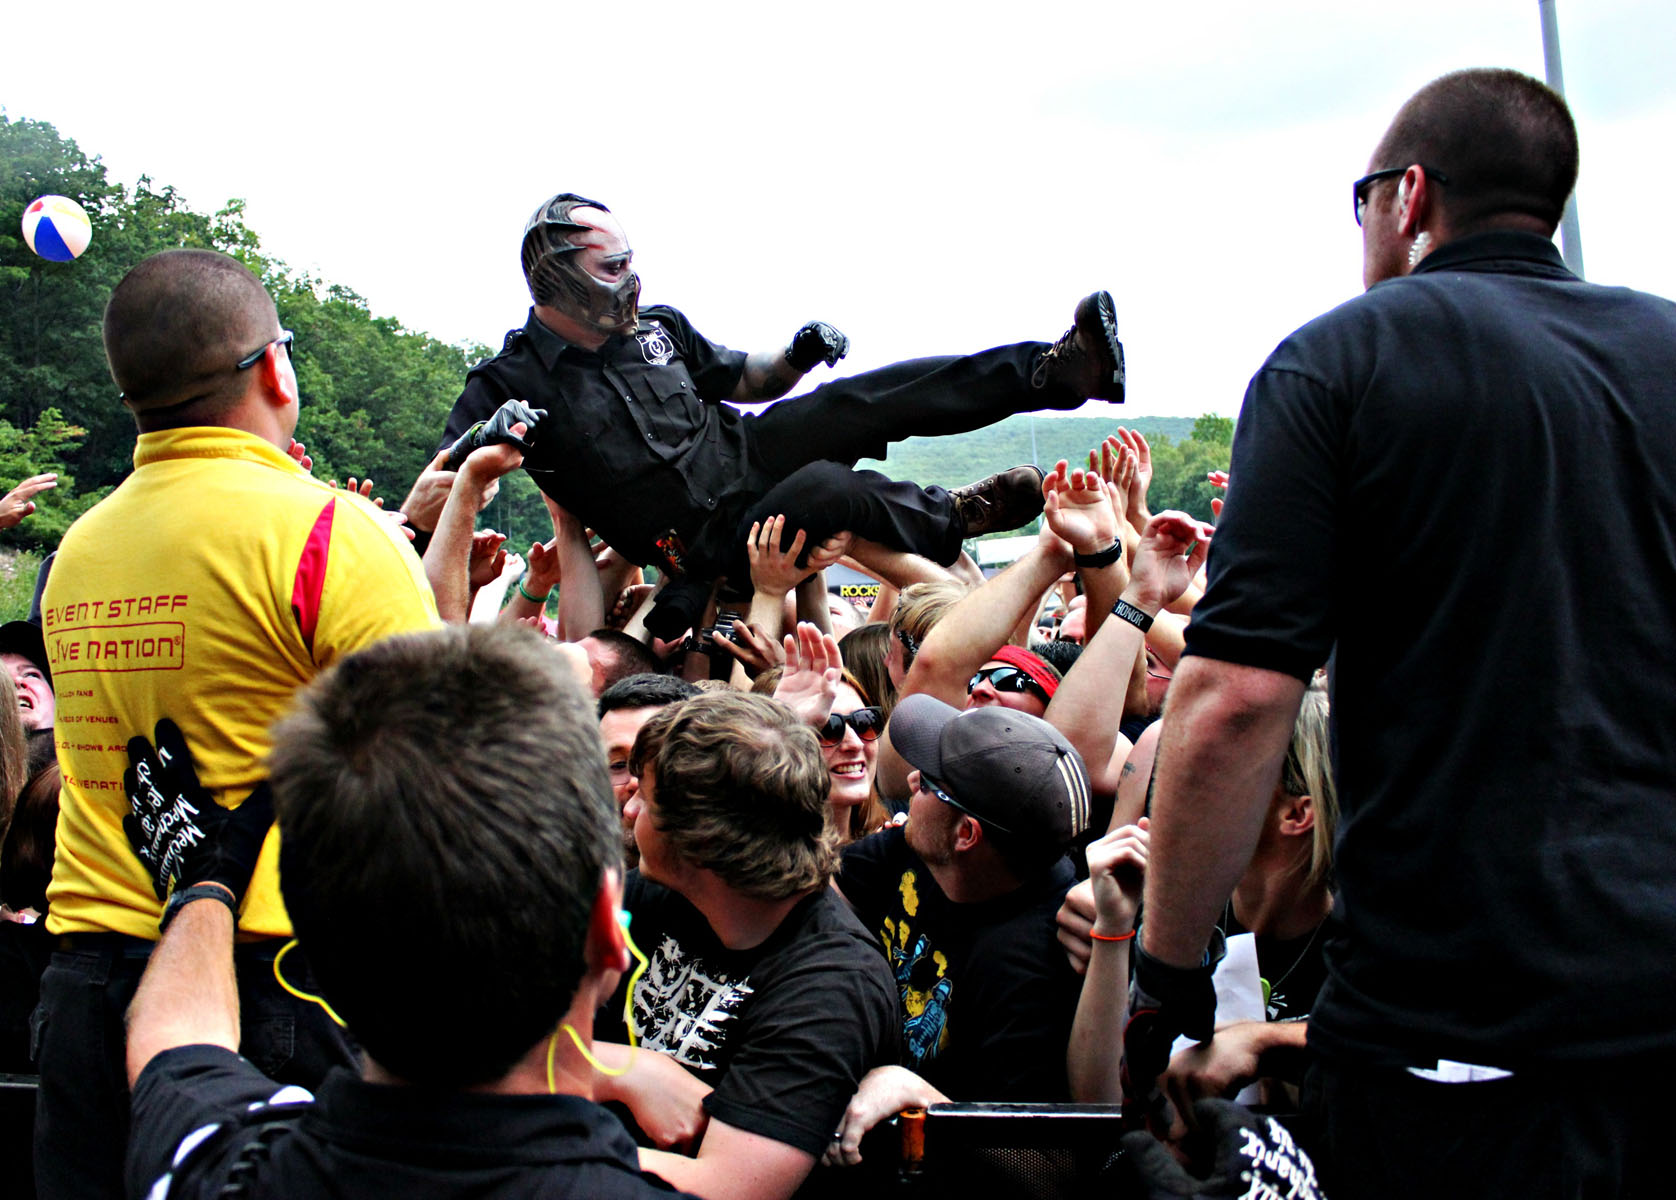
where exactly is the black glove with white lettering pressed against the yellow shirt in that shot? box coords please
[122,717,273,907]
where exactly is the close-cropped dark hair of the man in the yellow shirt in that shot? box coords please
[104,250,280,414]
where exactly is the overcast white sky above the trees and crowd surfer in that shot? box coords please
[0,0,1676,416]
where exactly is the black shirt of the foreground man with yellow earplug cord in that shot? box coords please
[127,1046,680,1200]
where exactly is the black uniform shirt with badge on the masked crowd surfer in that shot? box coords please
[442,305,760,565]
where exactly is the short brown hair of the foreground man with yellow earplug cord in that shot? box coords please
[270,625,622,1088]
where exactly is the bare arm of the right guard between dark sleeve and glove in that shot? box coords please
[1141,657,1304,967]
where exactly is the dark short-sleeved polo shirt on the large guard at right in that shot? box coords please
[1187,233,1676,1069]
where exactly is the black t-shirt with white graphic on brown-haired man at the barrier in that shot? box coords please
[595,872,902,1155]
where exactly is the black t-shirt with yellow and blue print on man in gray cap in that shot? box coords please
[838,828,1081,1101]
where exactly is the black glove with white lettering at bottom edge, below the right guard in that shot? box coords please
[1118,1099,1327,1200]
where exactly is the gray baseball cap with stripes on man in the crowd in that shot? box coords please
[890,696,1088,845]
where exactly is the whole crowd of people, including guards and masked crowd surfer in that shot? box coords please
[0,70,1676,1200]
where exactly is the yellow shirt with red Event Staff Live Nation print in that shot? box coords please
[42,427,439,939]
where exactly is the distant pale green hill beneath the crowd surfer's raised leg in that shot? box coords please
[858,412,1193,488]
